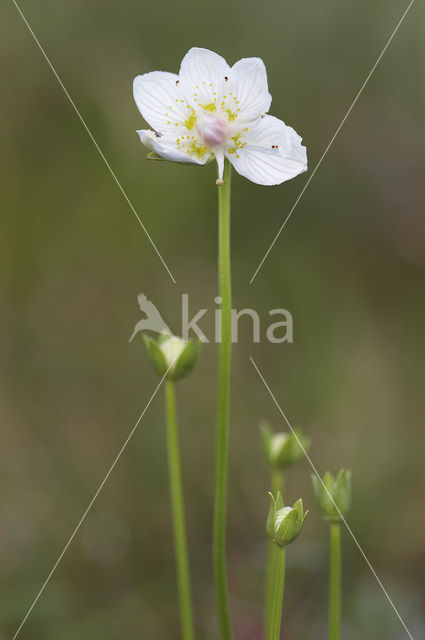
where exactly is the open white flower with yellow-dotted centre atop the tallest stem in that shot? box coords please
[133,47,307,185]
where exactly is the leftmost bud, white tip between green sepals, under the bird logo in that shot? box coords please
[143,333,201,381]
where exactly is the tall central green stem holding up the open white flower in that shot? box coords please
[213,159,232,640]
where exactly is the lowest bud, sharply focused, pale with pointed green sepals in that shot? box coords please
[266,491,308,547]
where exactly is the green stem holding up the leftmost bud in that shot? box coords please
[165,381,194,640]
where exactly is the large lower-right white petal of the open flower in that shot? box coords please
[225,116,307,185]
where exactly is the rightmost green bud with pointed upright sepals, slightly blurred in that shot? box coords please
[311,469,351,522]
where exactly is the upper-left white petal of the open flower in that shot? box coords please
[133,71,187,132]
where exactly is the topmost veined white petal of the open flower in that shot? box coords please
[179,47,230,103]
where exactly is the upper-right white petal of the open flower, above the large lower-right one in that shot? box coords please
[231,58,272,121]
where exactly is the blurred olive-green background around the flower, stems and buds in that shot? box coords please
[0,0,425,640]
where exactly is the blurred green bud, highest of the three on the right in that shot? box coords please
[260,422,311,471]
